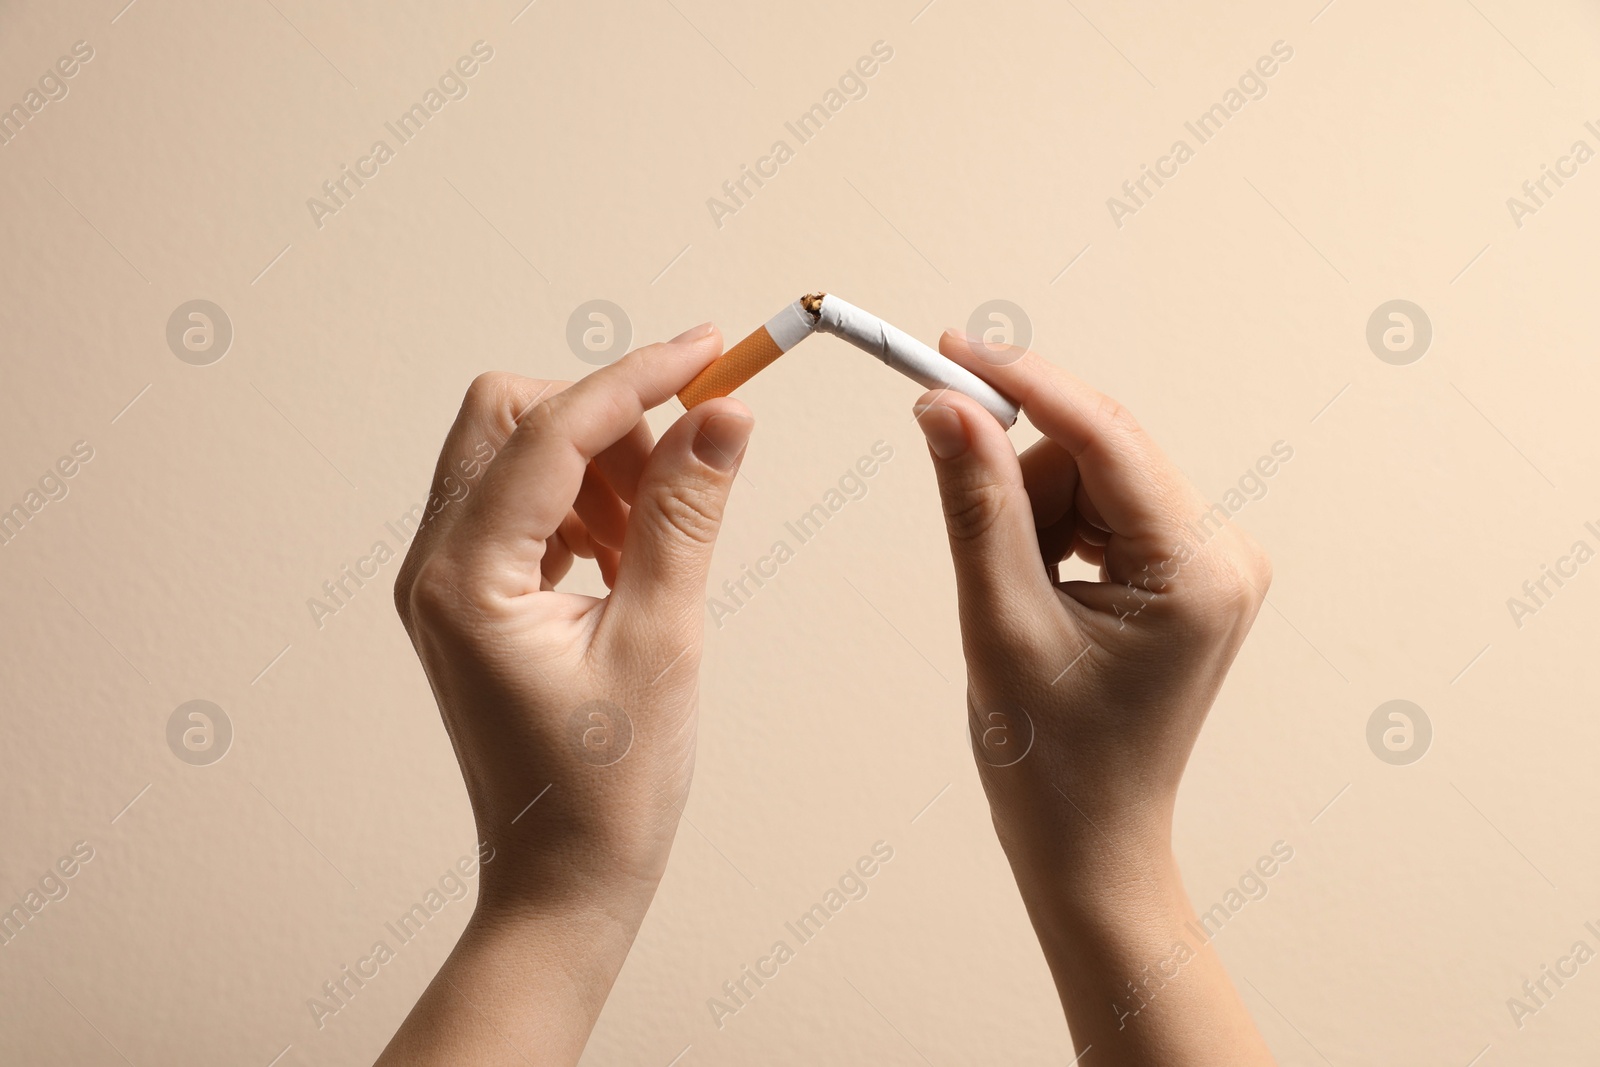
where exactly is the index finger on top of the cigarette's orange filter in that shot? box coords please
[458,323,722,592]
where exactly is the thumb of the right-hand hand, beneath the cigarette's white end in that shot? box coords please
[914,389,1056,632]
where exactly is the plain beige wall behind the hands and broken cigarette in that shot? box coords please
[0,0,1600,1067]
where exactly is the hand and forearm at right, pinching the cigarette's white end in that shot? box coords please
[917,333,1274,1067]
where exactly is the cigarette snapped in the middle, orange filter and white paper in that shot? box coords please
[678,293,1018,429]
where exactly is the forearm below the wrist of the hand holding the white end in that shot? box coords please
[1018,846,1274,1067]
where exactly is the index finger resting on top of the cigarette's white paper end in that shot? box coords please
[939,330,1194,537]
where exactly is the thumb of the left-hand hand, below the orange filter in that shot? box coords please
[611,397,755,639]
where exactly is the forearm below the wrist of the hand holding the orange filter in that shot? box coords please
[378,901,648,1067]
